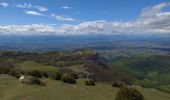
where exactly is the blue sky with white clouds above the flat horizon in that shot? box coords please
[0,0,170,35]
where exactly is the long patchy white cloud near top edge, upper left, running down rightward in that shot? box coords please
[15,3,48,12]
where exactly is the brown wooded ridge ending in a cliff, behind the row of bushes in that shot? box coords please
[0,49,132,84]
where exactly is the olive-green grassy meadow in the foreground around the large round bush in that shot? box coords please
[0,76,170,100]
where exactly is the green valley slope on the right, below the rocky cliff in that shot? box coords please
[99,54,170,92]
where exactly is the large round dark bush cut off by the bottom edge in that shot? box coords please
[115,87,145,100]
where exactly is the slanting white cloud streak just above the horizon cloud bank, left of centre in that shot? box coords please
[51,14,76,21]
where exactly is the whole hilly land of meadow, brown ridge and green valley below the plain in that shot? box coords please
[0,49,170,100]
